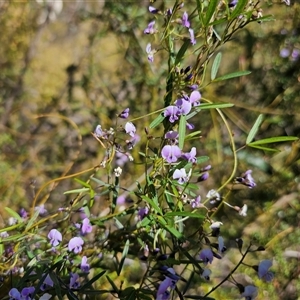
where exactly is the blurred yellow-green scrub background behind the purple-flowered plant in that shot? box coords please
[0,0,300,299]
